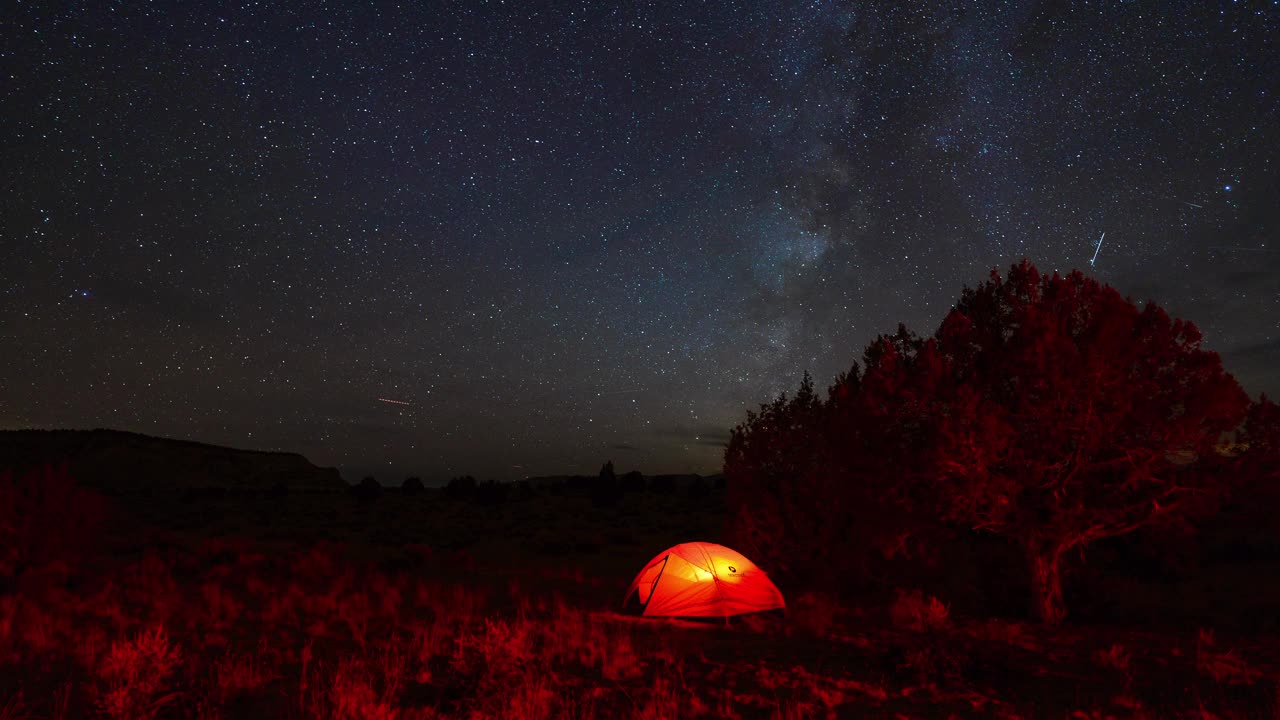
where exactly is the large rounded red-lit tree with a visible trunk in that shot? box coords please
[885,261,1248,624]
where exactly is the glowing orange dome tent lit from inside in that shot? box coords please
[623,542,786,618]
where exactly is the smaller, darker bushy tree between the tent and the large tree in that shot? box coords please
[724,358,931,596]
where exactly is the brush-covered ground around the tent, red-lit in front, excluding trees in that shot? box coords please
[0,474,1280,720]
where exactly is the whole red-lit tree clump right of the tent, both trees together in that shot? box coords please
[724,261,1249,624]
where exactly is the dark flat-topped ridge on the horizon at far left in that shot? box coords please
[0,429,348,495]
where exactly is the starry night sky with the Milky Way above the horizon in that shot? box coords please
[0,0,1280,483]
